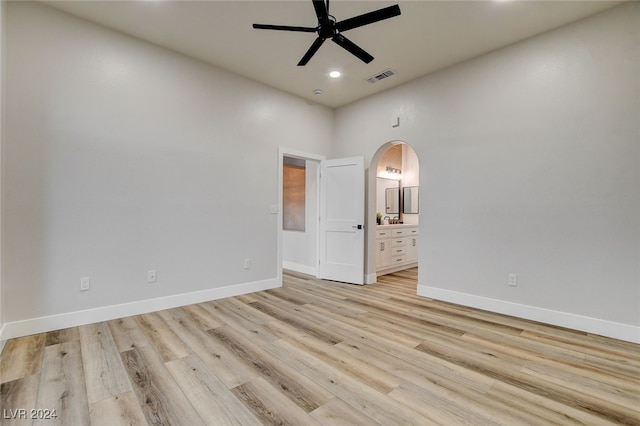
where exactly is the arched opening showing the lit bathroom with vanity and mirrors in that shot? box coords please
[366,141,420,284]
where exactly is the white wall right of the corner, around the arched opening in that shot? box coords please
[331,2,640,342]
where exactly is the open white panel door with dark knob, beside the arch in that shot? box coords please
[318,157,364,284]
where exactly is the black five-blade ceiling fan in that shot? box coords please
[253,0,400,66]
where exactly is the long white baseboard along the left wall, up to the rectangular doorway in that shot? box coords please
[0,278,282,342]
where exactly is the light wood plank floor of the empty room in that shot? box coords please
[0,269,640,426]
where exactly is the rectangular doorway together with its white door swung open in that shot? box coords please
[272,148,365,284]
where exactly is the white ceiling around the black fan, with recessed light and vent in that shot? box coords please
[45,0,621,108]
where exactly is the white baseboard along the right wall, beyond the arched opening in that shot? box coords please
[418,284,640,343]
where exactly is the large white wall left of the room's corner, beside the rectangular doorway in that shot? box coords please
[2,2,333,337]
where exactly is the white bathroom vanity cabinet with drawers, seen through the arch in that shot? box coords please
[376,225,418,275]
